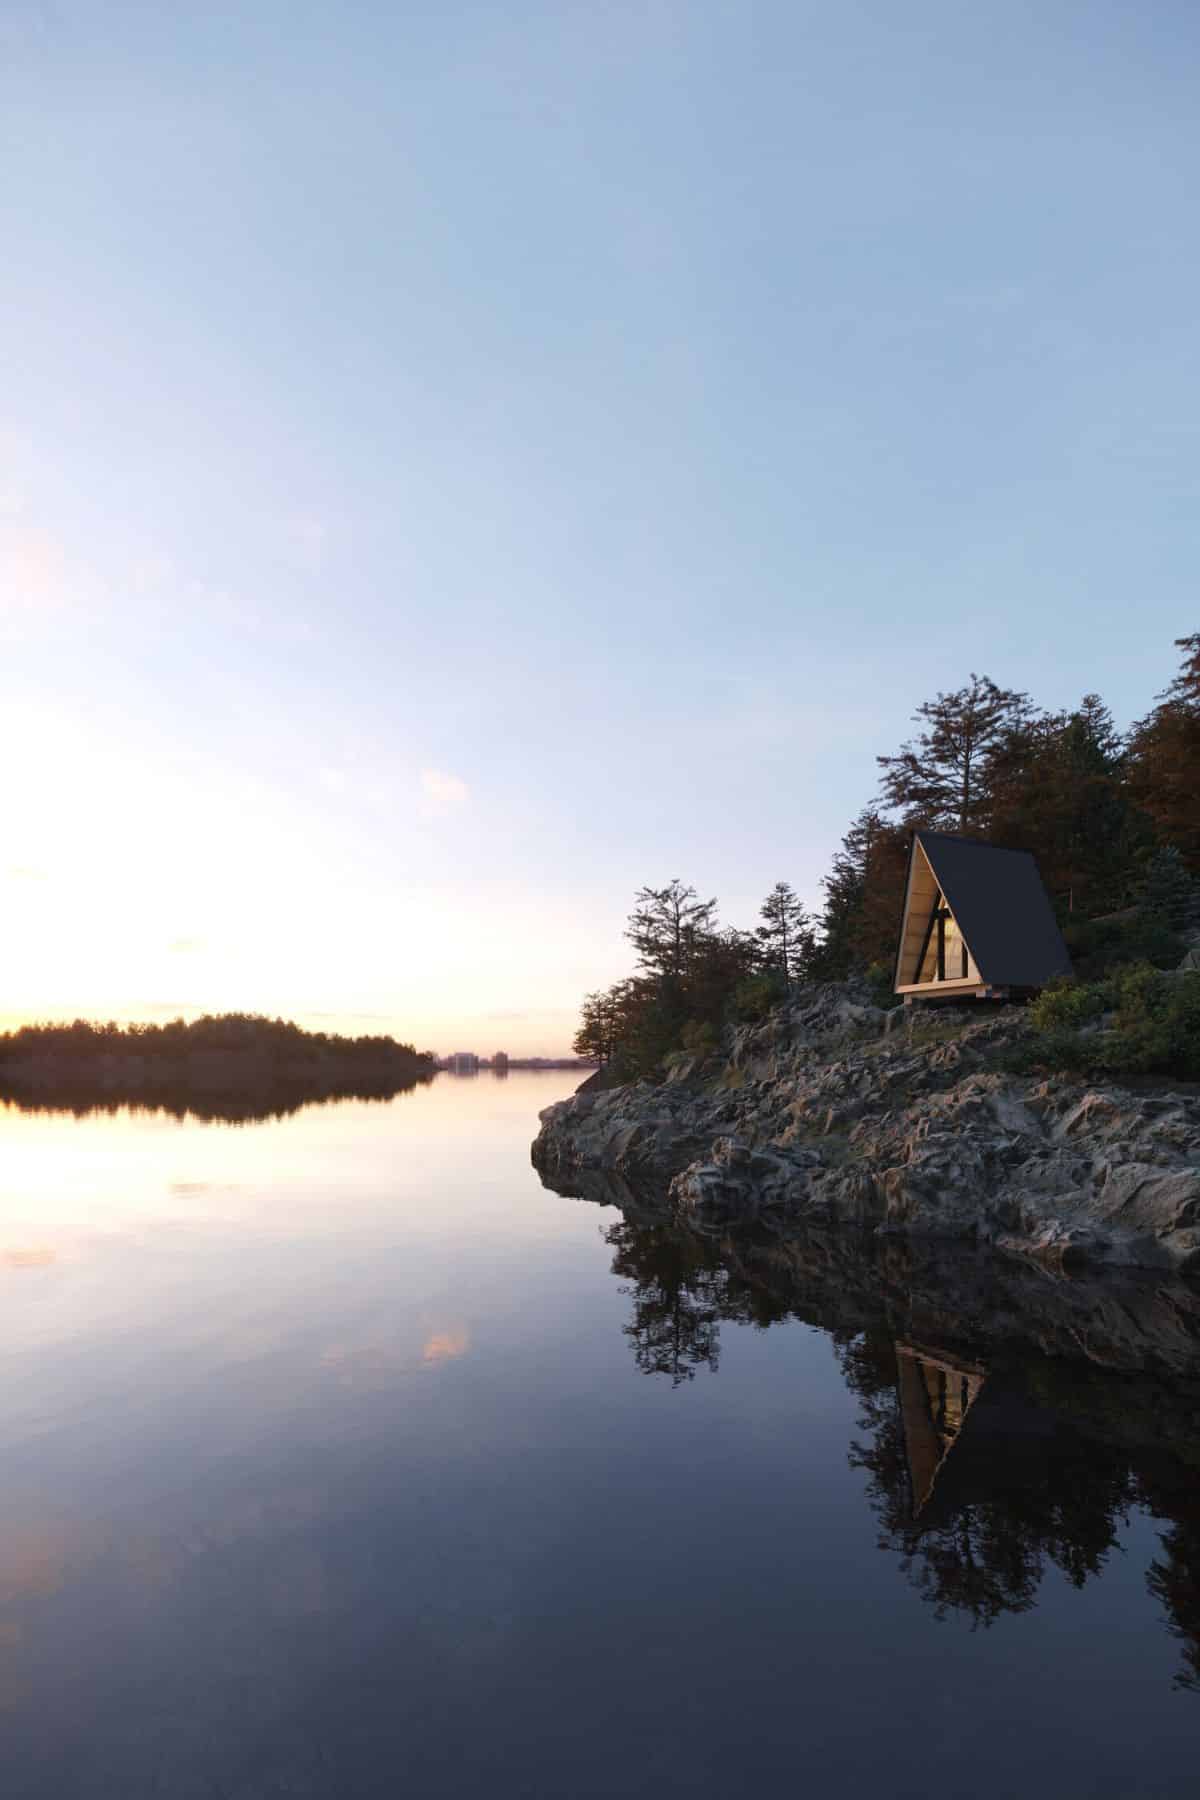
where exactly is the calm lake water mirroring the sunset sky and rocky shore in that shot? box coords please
[0,1073,1200,1800]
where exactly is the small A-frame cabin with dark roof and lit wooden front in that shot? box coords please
[896,832,1070,1004]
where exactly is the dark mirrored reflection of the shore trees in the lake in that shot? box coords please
[604,1219,1200,1692]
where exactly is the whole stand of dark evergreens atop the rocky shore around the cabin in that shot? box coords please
[574,632,1200,1078]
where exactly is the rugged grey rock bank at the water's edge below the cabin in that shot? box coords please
[533,985,1200,1274]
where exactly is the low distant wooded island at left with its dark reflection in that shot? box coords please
[0,1013,437,1112]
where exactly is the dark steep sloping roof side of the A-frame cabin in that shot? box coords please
[916,832,1070,988]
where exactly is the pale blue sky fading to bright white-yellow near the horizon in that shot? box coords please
[0,0,1200,1051]
